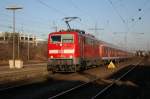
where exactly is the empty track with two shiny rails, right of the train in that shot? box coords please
[48,61,142,99]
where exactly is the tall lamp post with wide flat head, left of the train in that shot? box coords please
[6,5,22,67]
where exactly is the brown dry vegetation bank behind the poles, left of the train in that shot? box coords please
[0,42,47,65]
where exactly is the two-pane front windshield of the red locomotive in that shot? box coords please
[51,34,74,43]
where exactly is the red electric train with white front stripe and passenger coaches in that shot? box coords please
[47,30,130,72]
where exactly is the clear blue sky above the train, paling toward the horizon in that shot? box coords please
[0,0,150,50]
